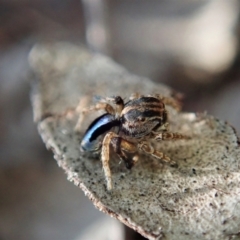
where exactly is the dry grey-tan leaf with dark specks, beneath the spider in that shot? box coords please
[29,43,240,239]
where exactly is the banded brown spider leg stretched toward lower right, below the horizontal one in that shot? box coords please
[138,142,175,164]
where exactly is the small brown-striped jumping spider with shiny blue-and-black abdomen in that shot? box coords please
[79,94,187,190]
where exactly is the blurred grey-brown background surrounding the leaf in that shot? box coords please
[0,0,240,240]
